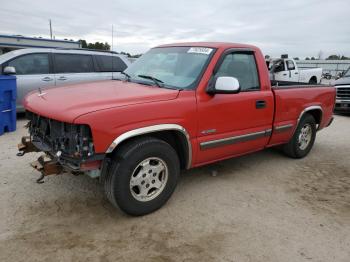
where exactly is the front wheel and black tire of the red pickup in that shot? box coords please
[104,137,180,216]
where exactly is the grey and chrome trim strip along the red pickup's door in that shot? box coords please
[200,129,272,150]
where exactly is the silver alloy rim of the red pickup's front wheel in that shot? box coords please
[130,157,169,202]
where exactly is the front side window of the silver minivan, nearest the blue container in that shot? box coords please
[8,54,50,75]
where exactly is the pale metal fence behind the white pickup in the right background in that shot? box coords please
[296,60,350,76]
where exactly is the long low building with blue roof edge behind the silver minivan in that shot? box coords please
[0,35,81,54]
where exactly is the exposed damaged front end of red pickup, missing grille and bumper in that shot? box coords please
[17,111,105,181]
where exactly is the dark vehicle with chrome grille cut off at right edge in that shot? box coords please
[334,67,350,112]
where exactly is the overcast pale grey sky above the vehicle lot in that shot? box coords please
[0,0,350,58]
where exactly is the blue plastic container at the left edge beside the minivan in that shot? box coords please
[0,75,17,135]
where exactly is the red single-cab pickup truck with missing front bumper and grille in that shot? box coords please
[19,43,335,215]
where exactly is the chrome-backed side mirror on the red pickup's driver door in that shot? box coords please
[207,76,240,94]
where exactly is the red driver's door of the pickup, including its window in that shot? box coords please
[196,50,274,164]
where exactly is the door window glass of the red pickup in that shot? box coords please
[216,53,260,91]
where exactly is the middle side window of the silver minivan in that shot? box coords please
[54,54,95,73]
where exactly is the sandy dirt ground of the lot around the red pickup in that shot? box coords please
[0,116,350,262]
